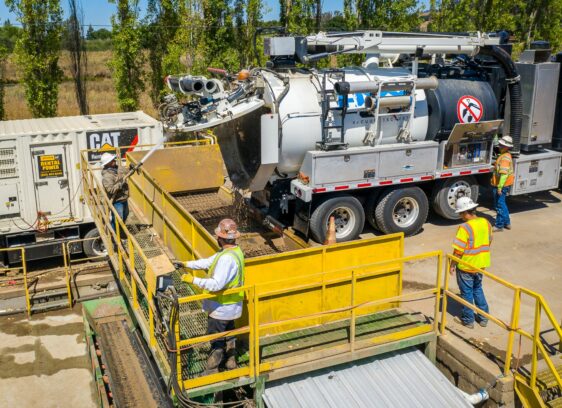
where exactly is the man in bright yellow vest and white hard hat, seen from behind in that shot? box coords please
[449,197,492,329]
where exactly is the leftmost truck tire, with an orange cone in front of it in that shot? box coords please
[310,195,365,243]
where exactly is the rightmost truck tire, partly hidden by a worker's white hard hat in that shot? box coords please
[431,176,478,220]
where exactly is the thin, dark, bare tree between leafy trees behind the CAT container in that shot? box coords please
[67,0,87,115]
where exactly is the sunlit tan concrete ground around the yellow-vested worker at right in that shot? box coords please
[358,191,562,364]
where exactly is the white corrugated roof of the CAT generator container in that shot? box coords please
[0,111,158,136]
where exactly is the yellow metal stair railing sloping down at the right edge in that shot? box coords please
[441,255,562,404]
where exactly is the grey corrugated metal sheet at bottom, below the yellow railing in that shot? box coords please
[264,349,472,408]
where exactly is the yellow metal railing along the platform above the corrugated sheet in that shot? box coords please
[175,251,443,389]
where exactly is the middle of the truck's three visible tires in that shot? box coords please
[375,187,429,236]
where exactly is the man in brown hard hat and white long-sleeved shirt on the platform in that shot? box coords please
[174,219,244,374]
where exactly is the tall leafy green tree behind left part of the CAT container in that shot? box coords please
[6,0,62,117]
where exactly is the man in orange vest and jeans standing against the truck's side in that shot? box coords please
[492,136,514,232]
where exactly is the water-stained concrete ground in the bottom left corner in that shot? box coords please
[0,309,97,408]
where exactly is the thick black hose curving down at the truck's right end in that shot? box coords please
[480,45,523,153]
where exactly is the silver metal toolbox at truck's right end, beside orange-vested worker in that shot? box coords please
[511,150,562,195]
